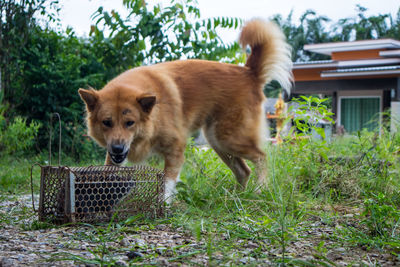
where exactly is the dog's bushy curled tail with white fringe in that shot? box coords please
[239,19,293,94]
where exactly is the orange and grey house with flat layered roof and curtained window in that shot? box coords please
[292,39,400,132]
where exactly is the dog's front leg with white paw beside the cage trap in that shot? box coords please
[164,151,185,204]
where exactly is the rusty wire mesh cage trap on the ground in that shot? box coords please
[31,114,165,223]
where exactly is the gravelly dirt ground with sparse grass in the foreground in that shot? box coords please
[0,196,400,267]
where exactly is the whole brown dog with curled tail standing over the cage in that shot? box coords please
[79,20,292,200]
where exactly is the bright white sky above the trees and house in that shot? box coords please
[60,0,400,42]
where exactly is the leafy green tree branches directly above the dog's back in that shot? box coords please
[90,0,241,81]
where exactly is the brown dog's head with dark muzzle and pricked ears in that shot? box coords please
[78,88,156,165]
